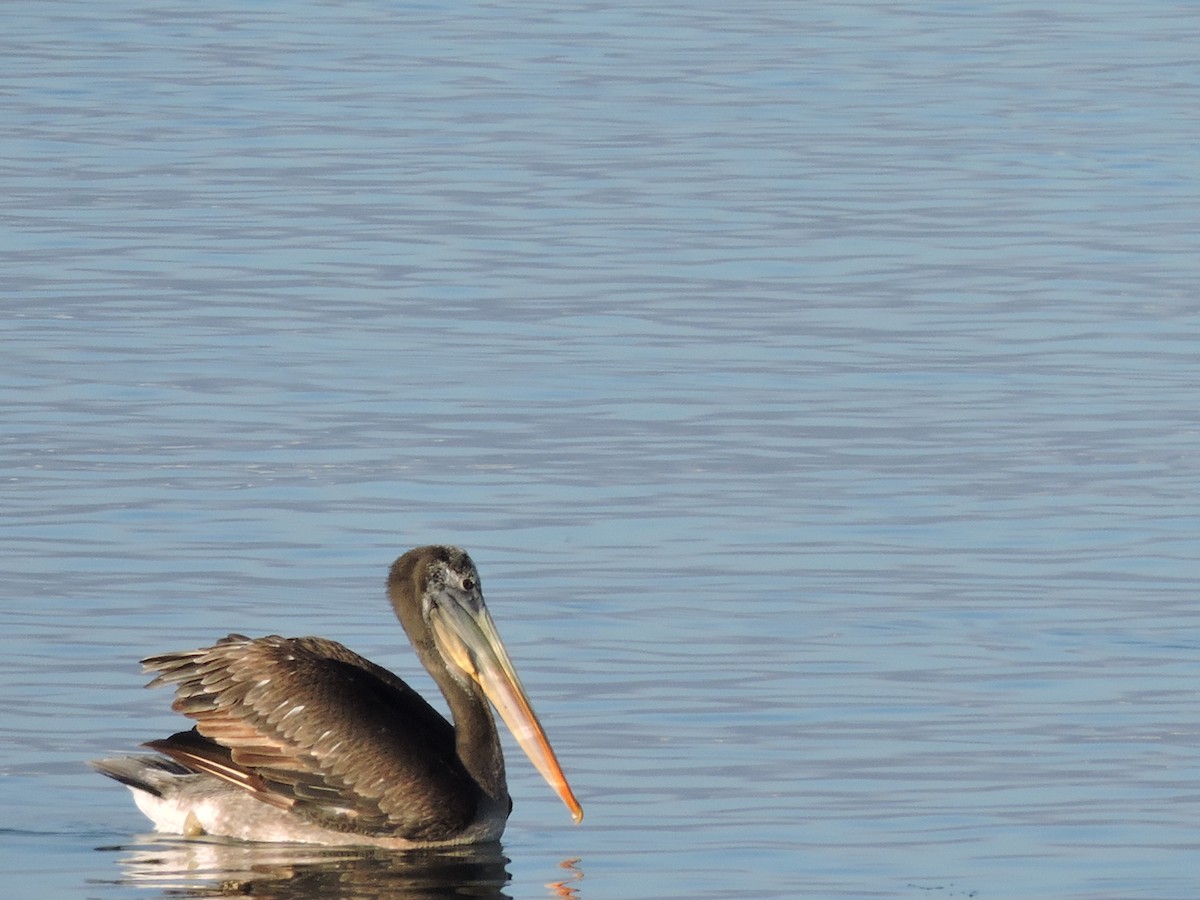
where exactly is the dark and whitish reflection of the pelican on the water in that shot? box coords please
[90,835,577,900]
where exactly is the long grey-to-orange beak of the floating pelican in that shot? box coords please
[430,593,583,823]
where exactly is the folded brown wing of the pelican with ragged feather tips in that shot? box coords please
[143,635,479,840]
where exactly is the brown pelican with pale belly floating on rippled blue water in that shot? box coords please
[91,546,583,848]
